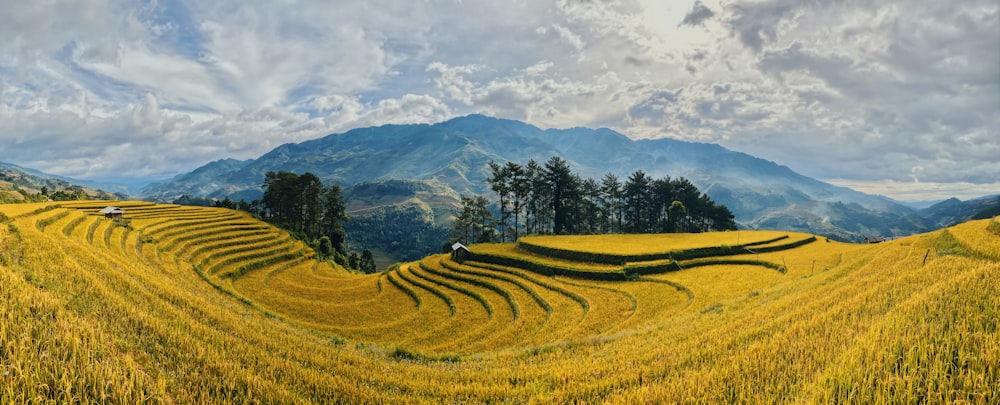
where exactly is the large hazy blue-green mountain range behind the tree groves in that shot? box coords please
[143,115,930,240]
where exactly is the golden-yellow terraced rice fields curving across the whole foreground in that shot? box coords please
[0,201,1000,404]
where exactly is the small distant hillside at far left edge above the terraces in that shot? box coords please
[0,162,127,203]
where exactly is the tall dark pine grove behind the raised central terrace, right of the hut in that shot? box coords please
[452,157,736,243]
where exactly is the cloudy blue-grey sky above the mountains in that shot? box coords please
[0,0,1000,200]
